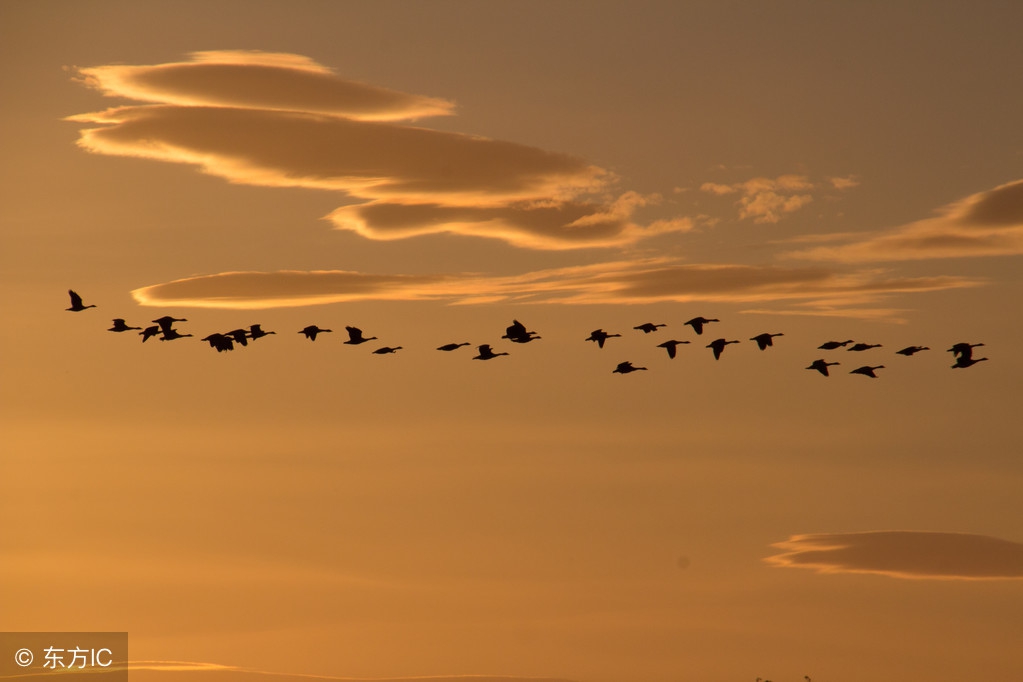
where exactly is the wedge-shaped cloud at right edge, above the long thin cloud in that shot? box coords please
[786,180,1023,263]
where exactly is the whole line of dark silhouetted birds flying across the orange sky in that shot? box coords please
[65,289,987,378]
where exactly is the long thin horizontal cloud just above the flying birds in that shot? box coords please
[132,259,980,314]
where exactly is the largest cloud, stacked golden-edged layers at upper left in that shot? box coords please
[68,51,694,249]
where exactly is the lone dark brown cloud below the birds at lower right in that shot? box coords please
[764,531,1023,580]
